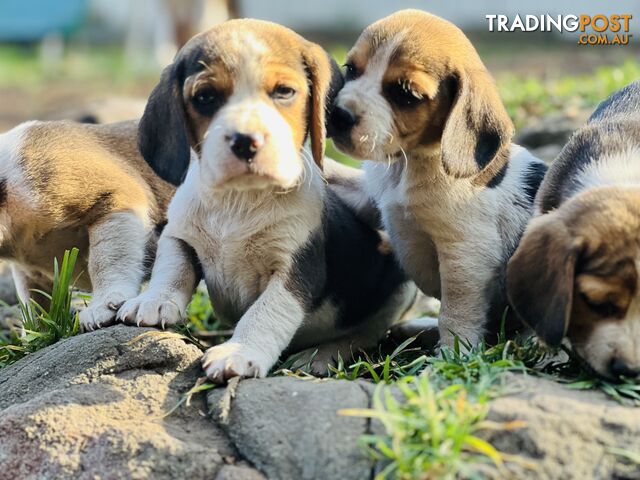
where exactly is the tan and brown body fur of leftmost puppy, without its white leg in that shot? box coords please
[2,121,173,289]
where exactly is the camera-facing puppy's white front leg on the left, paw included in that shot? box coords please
[118,233,199,328]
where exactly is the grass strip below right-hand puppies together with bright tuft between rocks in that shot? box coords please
[277,326,640,480]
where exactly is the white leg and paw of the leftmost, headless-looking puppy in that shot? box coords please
[80,211,150,330]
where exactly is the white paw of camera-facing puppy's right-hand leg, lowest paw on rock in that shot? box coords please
[202,341,273,383]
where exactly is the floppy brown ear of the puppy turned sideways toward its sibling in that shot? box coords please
[441,66,514,178]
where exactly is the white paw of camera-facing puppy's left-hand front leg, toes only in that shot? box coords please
[118,291,184,328]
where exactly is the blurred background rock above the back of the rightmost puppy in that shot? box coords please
[514,110,590,149]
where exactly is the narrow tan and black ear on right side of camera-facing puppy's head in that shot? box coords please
[303,43,344,168]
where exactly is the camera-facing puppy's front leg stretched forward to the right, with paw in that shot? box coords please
[202,276,305,383]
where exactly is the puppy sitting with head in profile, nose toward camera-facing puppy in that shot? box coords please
[330,10,546,345]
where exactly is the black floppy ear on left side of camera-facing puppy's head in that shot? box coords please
[138,63,191,185]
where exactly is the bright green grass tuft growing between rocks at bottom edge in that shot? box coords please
[339,375,519,480]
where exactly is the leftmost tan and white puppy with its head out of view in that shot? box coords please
[0,121,174,330]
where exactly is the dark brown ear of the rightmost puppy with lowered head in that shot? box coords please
[507,213,583,346]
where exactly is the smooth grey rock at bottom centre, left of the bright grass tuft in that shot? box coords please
[208,377,373,480]
